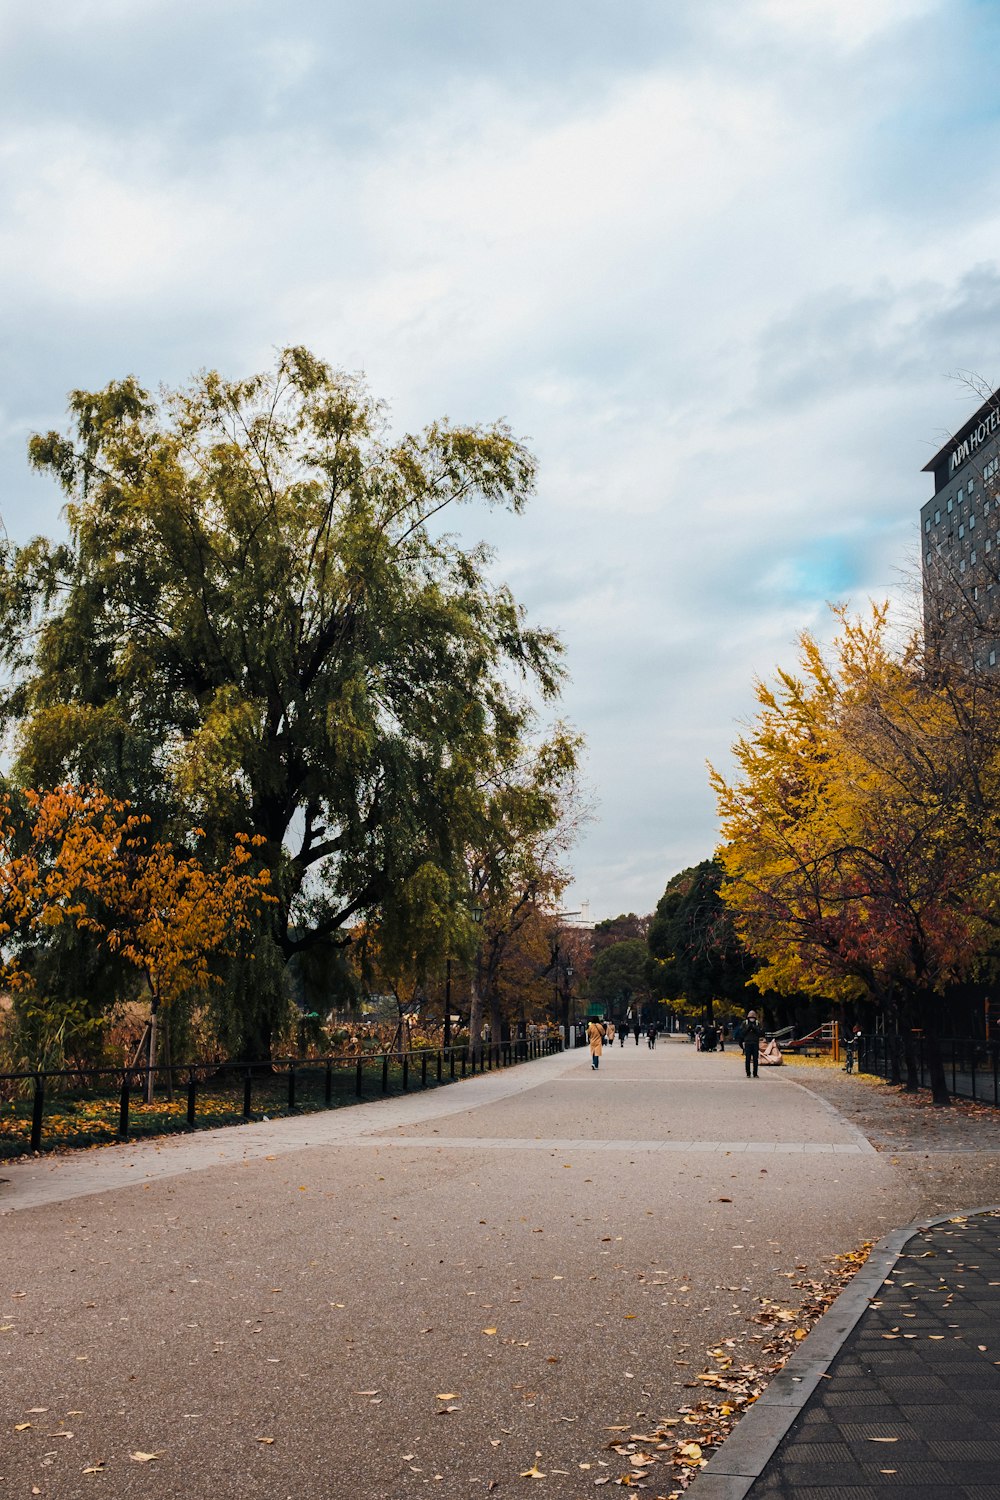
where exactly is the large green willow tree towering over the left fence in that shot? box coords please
[0,348,561,1049]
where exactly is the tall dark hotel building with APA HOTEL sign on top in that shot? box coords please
[921,392,1000,669]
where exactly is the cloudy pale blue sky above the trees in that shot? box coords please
[0,0,1000,918]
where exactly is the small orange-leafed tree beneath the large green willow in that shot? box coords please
[0,785,273,1092]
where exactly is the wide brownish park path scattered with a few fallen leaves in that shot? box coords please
[0,1041,987,1500]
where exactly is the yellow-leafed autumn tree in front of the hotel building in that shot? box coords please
[714,608,1000,1103]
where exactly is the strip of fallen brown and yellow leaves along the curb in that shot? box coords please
[590,1242,871,1500]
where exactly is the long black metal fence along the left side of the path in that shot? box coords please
[0,1037,562,1160]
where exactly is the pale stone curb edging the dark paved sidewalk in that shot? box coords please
[688,1203,1000,1500]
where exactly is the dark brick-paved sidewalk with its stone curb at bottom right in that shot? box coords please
[690,1209,1000,1500]
